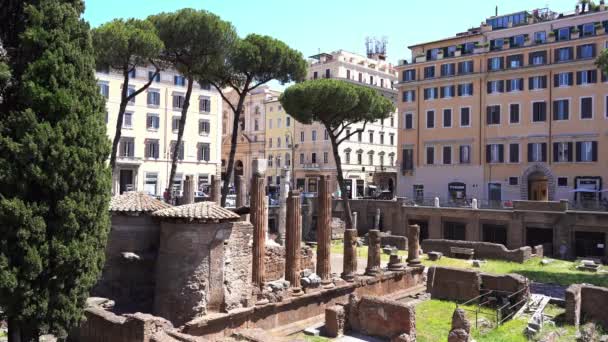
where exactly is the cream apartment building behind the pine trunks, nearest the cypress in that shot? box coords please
[96,66,222,196]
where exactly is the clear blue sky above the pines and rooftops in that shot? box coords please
[84,0,576,63]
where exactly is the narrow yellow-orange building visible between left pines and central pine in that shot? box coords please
[264,96,298,194]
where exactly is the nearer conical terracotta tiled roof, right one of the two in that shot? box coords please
[152,201,240,221]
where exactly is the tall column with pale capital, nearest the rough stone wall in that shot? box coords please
[250,159,268,287]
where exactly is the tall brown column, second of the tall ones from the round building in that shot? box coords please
[285,190,302,295]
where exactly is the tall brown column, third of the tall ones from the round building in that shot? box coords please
[317,177,331,286]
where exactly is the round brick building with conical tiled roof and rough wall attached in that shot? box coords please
[153,202,253,325]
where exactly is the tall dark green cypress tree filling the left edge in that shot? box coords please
[0,0,110,342]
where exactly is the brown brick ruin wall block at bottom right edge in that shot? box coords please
[566,284,608,328]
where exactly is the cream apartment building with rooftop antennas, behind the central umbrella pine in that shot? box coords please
[294,49,397,198]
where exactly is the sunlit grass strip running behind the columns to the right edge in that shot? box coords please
[331,242,608,287]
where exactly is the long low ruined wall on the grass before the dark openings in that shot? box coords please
[422,239,532,262]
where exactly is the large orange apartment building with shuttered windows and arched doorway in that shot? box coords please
[396,5,608,203]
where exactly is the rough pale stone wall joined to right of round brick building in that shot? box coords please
[223,222,253,310]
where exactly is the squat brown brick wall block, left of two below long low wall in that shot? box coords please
[426,267,481,301]
